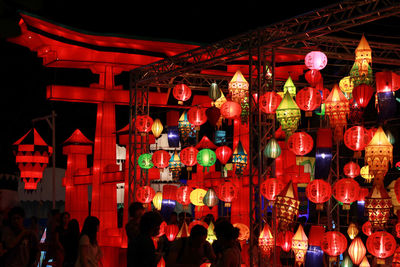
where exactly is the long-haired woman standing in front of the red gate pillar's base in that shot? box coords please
[75,216,102,267]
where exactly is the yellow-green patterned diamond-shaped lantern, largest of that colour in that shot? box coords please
[276,93,301,137]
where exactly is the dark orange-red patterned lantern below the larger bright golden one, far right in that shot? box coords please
[365,183,393,229]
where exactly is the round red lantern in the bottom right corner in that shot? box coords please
[367,231,396,264]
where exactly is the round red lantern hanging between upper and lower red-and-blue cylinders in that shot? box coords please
[306,179,332,210]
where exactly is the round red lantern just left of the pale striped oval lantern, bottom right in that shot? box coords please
[321,231,347,261]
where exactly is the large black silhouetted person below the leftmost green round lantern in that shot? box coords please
[127,211,162,267]
